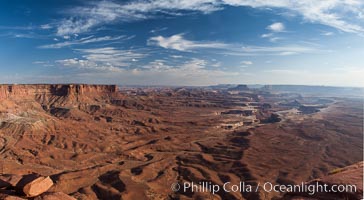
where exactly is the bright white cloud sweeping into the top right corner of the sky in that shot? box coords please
[224,0,364,33]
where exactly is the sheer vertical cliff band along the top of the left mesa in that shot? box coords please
[0,84,117,99]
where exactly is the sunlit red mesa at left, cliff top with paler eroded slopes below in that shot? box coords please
[0,84,118,141]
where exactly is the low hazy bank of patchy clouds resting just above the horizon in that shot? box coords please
[56,55,239,85]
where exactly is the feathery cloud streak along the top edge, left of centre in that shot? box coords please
[57,0,218,36]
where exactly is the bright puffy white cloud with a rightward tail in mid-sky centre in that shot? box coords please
[148,34,227,51]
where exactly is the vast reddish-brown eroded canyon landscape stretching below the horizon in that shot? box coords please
[0,84,363,200]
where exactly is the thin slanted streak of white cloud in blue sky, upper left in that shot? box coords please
[39,36,126,49]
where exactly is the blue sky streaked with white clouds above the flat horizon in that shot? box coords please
[0,0,364,87]
